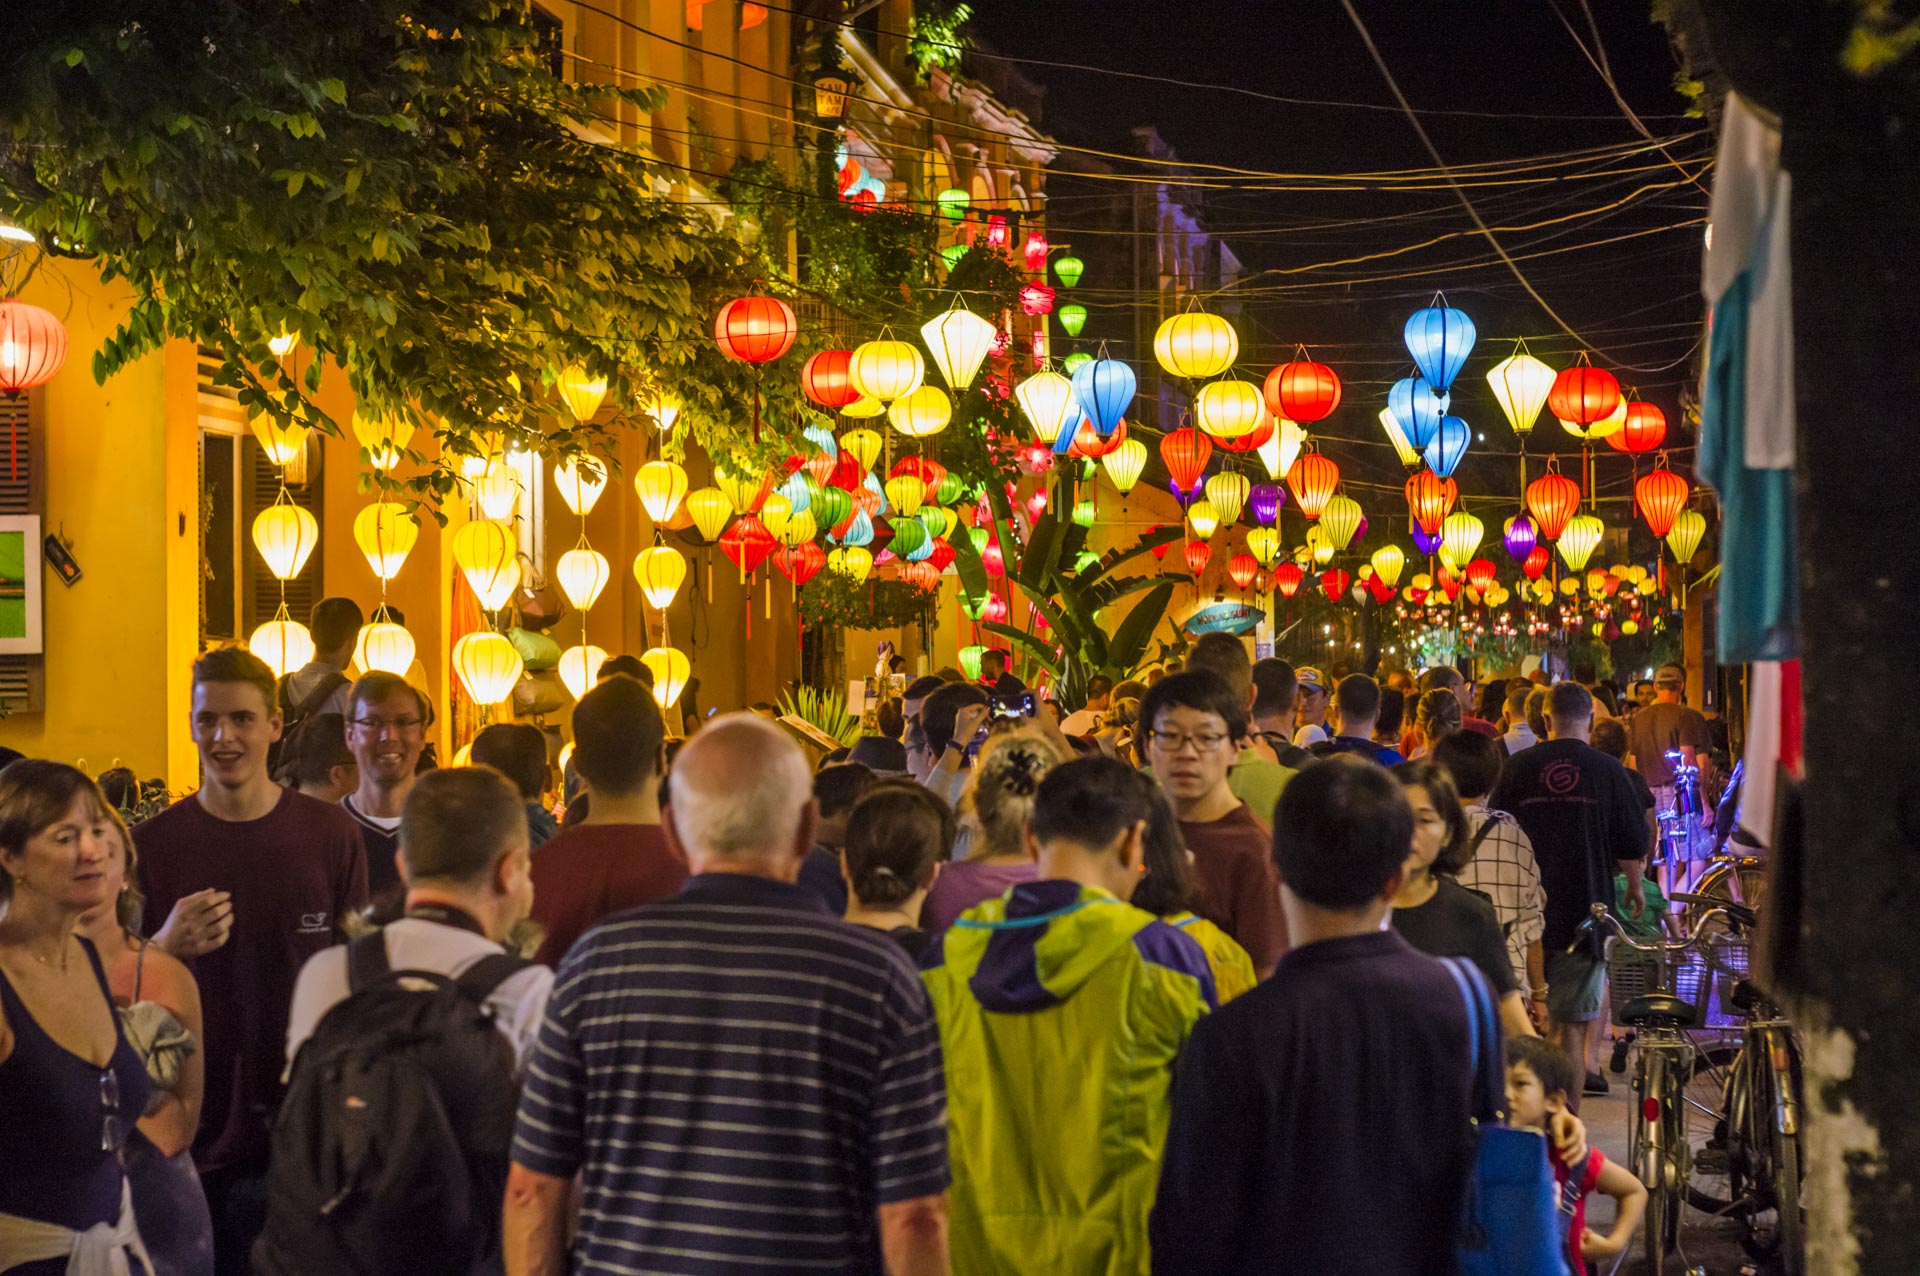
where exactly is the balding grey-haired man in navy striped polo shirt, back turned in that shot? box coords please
[505,714,948,1276]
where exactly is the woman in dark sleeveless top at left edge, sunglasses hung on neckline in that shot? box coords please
[0,760,152,1276]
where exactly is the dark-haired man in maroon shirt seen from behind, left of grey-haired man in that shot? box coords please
[534,675,687,967]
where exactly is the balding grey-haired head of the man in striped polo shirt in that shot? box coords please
[666,714,814,860]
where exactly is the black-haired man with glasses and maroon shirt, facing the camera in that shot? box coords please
[1140,670,1286,979]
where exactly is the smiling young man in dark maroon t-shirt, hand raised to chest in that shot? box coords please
[132,647,367,1276]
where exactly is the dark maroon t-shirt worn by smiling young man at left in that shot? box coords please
[132,789,367,1172]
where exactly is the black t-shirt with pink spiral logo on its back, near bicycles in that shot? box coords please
[1486,741,1647,952]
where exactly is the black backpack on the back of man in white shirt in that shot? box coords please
[253,931,530,1276]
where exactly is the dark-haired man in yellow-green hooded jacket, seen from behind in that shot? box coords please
[922,758,1215,1276]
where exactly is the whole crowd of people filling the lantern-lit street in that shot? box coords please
[0,601,1709,1276]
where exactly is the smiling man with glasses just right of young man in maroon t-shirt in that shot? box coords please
[340,672,434,921]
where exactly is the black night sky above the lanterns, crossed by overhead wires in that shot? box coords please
[973,0,1711,506]
